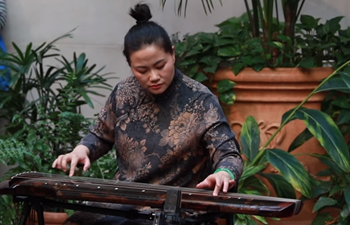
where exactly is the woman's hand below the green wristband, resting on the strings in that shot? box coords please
[196,171,236,196]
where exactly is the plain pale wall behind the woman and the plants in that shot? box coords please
[2,0,350,115]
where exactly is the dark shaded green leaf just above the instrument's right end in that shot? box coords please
[260,173,296,199]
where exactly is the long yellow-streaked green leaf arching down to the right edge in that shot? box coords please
[295,108,350,172]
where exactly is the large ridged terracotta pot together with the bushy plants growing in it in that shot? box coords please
[161,0,350,224]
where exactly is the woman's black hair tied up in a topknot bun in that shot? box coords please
[123,3,173,65]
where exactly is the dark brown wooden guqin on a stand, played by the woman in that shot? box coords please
[0,172,302,225]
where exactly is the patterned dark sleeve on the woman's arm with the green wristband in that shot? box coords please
[203,96,243,181]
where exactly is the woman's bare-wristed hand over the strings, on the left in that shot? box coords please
[52,145,90,176]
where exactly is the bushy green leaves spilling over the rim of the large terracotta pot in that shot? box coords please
[174,11,350,104]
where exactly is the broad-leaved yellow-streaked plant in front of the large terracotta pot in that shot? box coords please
[235,62,350,224]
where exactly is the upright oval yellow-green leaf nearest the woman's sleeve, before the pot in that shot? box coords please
[240,116,260,162]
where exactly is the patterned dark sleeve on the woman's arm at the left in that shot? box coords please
[79,87,117,162]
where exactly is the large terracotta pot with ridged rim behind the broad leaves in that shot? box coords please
[214,68,333,225]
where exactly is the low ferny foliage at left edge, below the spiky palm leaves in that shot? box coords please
[0,112,90,177]
